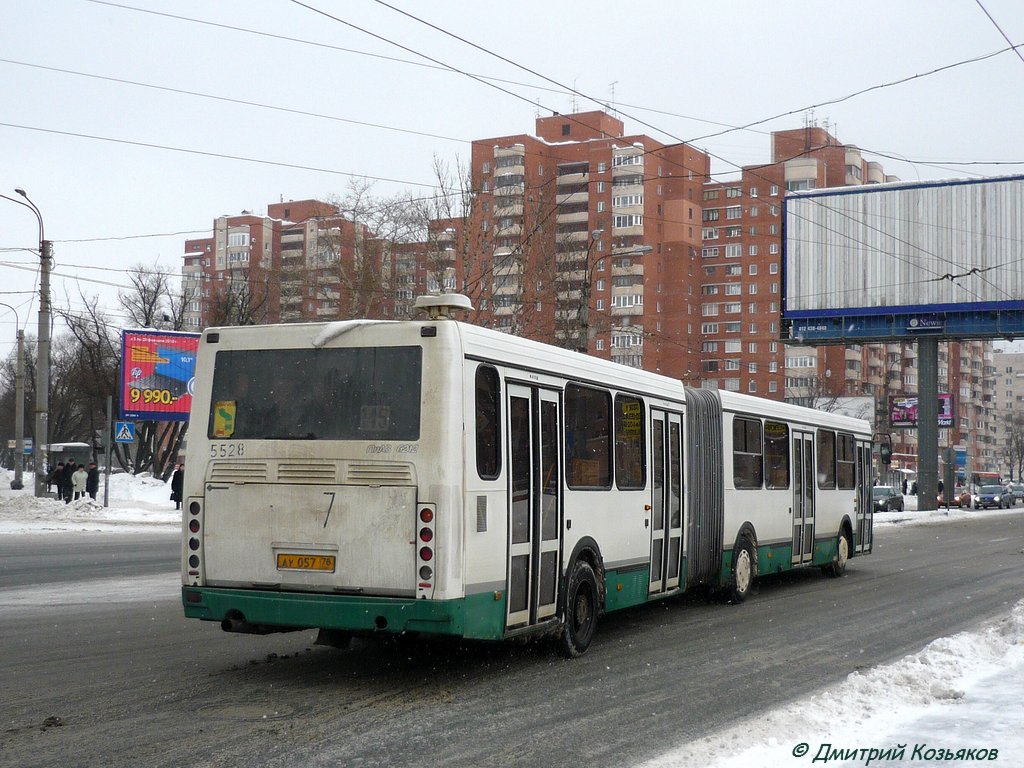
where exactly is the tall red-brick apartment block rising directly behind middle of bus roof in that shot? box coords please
[462,112,711,380]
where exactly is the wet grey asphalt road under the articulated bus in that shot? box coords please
[0,513,1024,768]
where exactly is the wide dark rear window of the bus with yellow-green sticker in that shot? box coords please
[208,347,422,440]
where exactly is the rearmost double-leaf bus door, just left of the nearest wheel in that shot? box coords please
[506,384,562,629]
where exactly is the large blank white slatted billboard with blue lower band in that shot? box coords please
[781,176,1024,343]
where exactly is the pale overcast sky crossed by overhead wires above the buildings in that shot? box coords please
[0,0,1024,355]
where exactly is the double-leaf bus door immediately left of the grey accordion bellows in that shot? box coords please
[649,409,683,594]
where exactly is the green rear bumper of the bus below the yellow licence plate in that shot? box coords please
[181,587,505,640]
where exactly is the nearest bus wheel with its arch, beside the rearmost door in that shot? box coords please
[558,540,604,658]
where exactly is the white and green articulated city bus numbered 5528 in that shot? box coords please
[181,296,871,655]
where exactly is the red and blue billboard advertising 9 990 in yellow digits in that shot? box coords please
[121,331,200,421]
